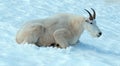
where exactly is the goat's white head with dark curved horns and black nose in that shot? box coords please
[84,8,102,37]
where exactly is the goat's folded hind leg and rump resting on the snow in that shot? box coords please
[17,25,44,44]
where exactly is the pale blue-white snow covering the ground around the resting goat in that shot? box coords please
[0,0,120,66]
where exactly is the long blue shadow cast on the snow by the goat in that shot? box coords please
[71,42,120,56]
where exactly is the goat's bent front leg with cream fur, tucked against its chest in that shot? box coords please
[53,29,71,48]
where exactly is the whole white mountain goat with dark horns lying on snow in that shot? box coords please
[16,8,102,48]
